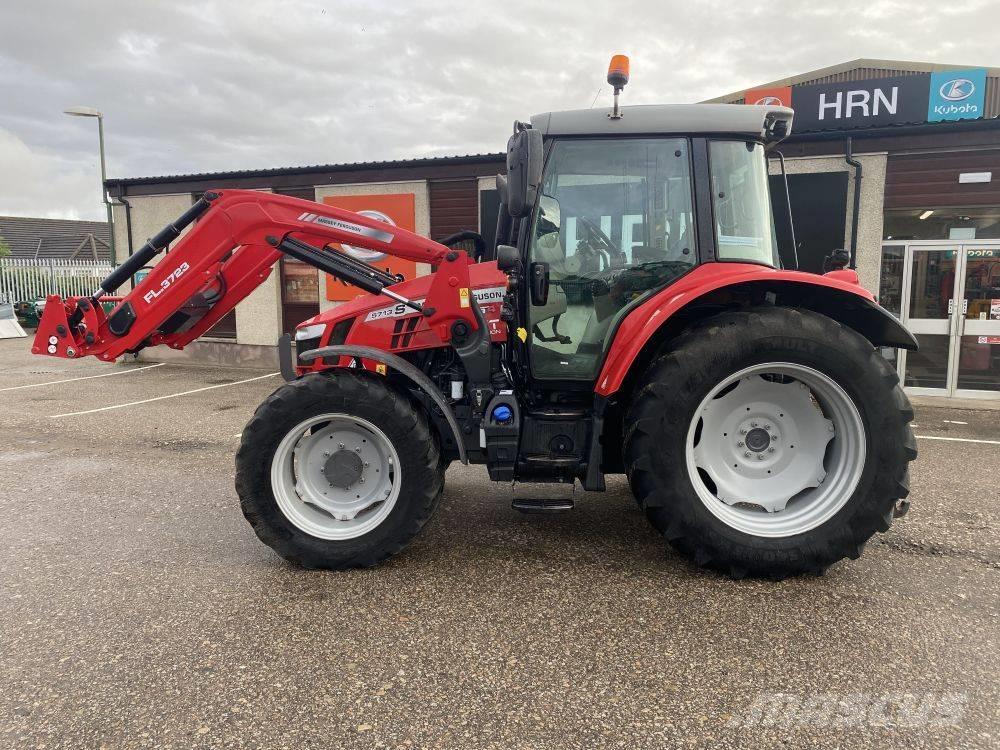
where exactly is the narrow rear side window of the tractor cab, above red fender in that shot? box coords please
[709,141,778,266]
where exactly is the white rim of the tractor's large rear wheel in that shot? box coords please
[685,362,866,537]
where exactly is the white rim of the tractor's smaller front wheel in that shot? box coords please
[271,414,400,540]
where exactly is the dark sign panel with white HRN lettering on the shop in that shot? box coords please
[792,73,930,132]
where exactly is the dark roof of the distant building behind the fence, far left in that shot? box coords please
[0,216,111,261]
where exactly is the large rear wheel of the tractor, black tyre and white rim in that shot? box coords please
[624,307,916,578]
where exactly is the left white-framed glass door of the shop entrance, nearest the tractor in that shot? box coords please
[903,250,962,395]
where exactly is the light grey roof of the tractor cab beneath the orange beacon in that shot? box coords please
[531,104,792,139]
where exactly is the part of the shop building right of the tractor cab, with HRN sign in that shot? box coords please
[712,60,1000,399]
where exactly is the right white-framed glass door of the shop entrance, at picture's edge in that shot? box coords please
[954,246,1000,398]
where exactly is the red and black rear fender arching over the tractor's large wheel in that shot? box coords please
[594,263,917,396]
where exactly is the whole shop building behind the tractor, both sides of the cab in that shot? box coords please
[107,60,1000,399]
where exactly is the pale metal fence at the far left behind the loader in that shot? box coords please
[0,258,114,303]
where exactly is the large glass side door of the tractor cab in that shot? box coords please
[527,138,697,381]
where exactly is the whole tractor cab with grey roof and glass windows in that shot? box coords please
[498,104,792,400]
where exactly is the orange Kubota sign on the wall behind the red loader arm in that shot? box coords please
[323,193,417,301]
